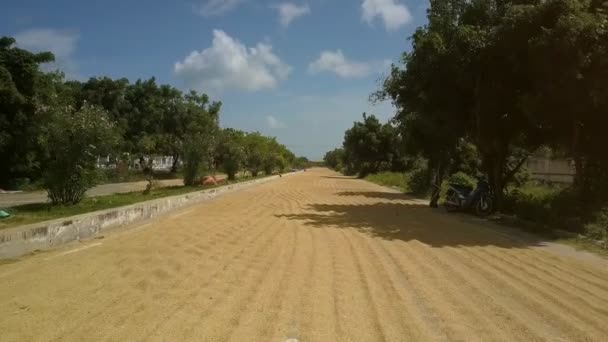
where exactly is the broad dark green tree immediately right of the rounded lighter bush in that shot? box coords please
[79,77,221,172]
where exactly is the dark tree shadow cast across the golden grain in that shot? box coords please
[277,201,540,248]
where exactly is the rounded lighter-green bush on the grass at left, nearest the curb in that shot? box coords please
[43,105,119,204]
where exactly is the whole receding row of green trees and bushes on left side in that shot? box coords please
[0,37,298,203]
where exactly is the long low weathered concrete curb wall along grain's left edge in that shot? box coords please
[0,173,294,259]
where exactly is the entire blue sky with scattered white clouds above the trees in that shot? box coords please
[0,0,427,160]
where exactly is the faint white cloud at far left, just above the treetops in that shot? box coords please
[15,28,80,78]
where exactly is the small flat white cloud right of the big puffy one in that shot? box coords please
[308,50,371,78]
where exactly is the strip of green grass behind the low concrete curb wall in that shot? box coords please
[0,175,266,229]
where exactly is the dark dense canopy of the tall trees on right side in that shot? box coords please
[373,0,608,208]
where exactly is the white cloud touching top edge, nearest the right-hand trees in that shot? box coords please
[361,0,412,31]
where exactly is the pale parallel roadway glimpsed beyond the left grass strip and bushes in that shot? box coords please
[0,179,184,208]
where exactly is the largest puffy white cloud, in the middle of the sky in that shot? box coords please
[174,30,291,91]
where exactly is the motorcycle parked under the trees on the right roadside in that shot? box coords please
[444,177,494,216]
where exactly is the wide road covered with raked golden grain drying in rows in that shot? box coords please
[0,169,608,341]
